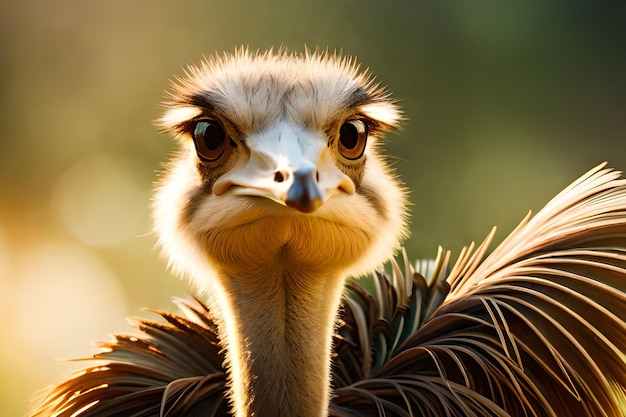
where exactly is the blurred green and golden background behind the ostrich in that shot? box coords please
[0,0,626,416]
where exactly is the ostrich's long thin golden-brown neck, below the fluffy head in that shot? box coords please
[212,269,344,417]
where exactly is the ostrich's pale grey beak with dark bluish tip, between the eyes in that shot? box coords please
[213,123,355,213]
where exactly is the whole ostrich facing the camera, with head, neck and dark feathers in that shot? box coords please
[32,50,626,417]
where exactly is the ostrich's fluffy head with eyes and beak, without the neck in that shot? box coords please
[155,52,405,286]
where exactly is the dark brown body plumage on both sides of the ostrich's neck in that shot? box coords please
[31,165,626,417]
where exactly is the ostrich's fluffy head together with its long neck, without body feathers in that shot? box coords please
[154,51,405,417]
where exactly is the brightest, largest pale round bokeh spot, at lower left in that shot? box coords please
[10,243,126,372]
